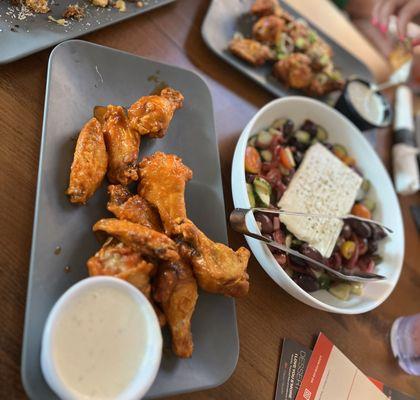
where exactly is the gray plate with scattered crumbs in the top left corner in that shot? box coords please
[0,0,174,64]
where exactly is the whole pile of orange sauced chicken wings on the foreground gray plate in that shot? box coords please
[66,88,250,357]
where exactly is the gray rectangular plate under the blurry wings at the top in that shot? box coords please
[201,0,372,100]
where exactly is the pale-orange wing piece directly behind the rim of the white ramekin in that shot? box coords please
[87,239,155,299]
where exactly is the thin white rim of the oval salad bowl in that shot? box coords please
[231,96,405,314]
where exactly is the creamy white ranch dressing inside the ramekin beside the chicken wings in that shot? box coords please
[52,286,147,399]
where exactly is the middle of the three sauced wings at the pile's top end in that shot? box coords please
[103,105,140,185]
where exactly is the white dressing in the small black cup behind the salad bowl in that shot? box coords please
[347,81,385,125]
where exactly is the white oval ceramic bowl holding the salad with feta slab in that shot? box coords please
[232,96,404,314]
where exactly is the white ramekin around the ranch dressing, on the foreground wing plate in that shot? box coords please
[41,276,162,400]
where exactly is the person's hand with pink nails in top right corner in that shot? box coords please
[372,0,420,46]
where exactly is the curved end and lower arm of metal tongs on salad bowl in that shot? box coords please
[229,208,386,282]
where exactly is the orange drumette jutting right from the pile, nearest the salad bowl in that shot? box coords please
[174,220,250,297]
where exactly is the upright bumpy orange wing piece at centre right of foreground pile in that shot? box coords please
[138,152,192,234]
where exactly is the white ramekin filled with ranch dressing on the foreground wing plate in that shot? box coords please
[41,277,162,400]
